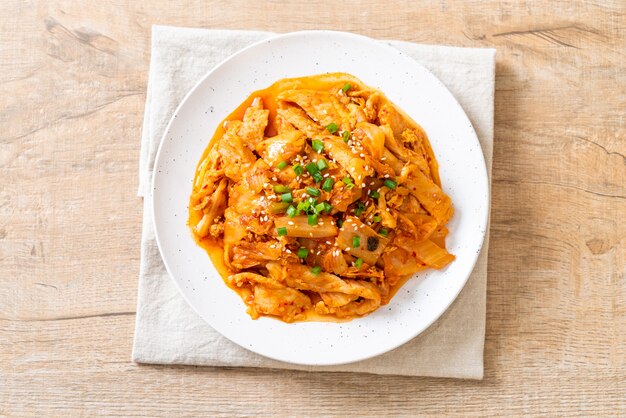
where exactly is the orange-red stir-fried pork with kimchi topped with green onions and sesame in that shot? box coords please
[189,73,454,322]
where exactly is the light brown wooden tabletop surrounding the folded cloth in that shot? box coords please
[0,0,626,417]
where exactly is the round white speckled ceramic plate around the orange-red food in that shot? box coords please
[153,31,489,365]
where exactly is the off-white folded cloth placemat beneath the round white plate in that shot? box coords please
[132,26,495,379]
